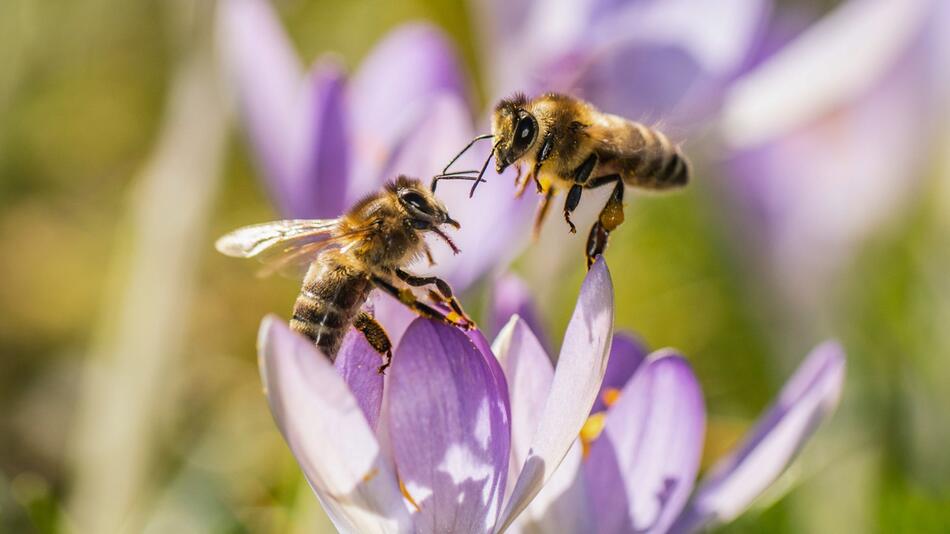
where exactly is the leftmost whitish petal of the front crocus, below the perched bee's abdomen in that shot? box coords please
[258,316,411,532]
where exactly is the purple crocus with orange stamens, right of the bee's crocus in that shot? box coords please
[506,332,844,533]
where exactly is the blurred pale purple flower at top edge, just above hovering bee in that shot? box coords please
[475,0,771,126]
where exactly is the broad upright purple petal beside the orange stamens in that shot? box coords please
[584,350,706,532]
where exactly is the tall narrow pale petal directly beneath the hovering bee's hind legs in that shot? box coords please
[498,258,614,530]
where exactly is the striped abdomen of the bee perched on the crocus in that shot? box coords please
[290,260,373,361]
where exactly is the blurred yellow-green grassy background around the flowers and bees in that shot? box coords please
[0,0,950,532]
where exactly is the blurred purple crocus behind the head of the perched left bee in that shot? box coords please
[219,0,532,294]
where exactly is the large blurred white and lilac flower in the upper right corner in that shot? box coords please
[722,0,950,310]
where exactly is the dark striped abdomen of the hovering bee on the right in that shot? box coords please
[619,122,690,189]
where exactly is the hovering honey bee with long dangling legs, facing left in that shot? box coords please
[432,93,690,268]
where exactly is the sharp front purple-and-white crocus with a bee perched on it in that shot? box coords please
[259,260,613,533]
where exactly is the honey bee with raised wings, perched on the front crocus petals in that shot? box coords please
[215,176,474,373]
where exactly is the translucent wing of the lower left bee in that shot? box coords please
[215,219,373,276]
